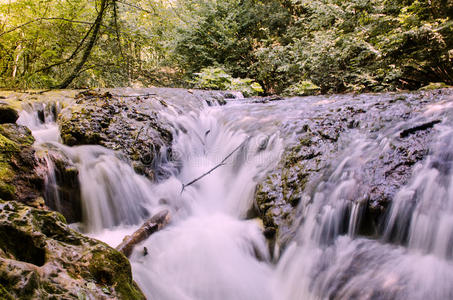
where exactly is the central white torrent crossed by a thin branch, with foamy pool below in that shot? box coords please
[128,108,282,300]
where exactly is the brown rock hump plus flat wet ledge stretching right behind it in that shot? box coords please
[58,88,228,179]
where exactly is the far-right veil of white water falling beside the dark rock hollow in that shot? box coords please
[385,126,453,259]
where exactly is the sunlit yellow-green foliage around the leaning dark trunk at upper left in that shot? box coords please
[0,0,178,88]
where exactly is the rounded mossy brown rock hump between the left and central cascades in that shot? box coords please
[59,91,172,179]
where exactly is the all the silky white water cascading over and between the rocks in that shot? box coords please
[15,89,453,300]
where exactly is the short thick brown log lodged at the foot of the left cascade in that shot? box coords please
[116,210,170,257]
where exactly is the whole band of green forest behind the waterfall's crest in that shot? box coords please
[0,0,453,95]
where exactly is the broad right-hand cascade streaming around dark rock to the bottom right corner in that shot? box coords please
[274,100,453,300]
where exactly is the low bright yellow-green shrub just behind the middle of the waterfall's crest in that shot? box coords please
[193,68,264,97]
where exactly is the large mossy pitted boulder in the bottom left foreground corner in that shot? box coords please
[0,201,145,299]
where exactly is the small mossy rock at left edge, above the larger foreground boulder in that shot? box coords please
[0,124,44,204]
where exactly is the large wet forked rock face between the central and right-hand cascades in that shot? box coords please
[255,89,453,244]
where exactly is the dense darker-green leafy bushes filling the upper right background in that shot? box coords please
[170,0,453,94]
